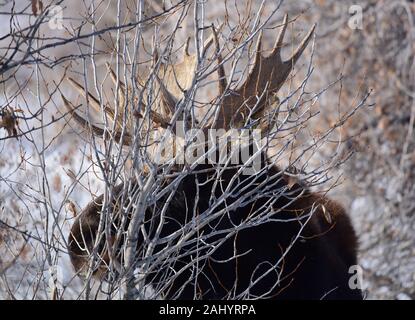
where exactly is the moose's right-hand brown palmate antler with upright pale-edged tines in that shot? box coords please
[214,15,315,129]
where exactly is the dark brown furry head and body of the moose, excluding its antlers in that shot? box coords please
[69,152,362,299]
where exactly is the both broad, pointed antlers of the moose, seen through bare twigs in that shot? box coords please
[62,15,315,149]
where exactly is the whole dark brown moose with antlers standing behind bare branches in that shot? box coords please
[62,15,362,300]
